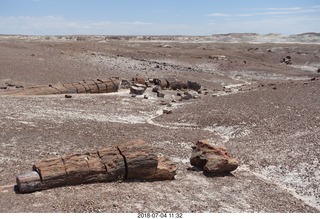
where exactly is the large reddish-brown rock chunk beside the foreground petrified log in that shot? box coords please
[190,140,239,174]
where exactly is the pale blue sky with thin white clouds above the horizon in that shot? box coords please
[0,0,320,36]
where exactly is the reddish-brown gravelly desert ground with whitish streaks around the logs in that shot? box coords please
[0,33,320,213]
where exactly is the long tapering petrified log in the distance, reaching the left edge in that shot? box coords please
[2,78,120,95]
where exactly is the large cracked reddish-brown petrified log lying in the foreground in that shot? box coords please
[16,140,177,193]
